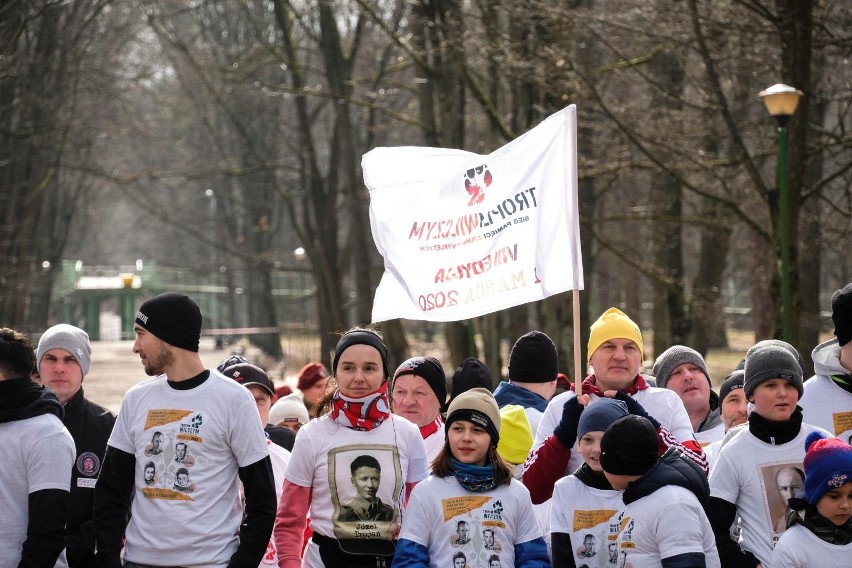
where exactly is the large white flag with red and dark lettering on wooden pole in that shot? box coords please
[361,105,583,322]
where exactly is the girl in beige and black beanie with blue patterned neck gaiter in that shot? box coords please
[393,388,550,568]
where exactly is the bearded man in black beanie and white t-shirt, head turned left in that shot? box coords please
[95,293,275,568]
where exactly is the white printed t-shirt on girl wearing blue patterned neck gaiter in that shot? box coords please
[399,476,541,568]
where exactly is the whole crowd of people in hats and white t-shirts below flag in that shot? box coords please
[0,284,852,568]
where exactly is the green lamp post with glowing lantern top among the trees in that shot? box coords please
[759,83,804,343]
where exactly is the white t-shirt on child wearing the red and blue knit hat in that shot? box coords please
[772,525,852,568]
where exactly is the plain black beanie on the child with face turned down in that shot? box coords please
[600,412,658,475]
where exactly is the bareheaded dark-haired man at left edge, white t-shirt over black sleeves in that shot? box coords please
[0,328,74,566]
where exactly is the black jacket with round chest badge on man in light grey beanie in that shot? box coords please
[63,388,115,568]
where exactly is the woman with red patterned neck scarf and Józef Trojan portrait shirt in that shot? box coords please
[274,328,427,568]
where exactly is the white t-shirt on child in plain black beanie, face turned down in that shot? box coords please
[616,485,721,568]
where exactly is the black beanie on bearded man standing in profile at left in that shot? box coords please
[136,292,201,353]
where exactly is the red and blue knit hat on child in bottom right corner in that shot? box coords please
[804,430,852,505]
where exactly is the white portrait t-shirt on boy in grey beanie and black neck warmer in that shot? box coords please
[710,423,832,568]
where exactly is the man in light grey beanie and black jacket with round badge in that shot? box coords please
[36,324,115,568]
